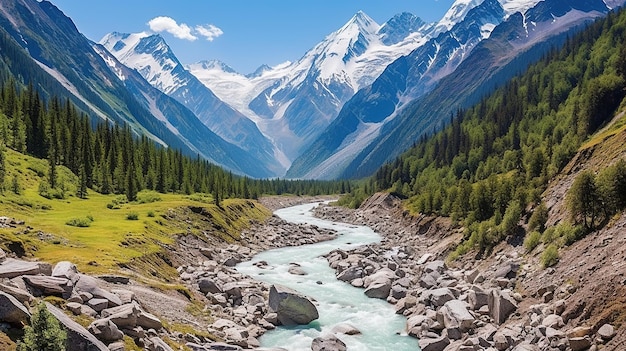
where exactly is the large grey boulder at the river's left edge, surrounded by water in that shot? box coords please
[269,285,319,326]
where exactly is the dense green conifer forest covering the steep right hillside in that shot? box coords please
[342,11,626,260]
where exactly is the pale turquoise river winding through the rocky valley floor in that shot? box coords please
[237,203,419,351]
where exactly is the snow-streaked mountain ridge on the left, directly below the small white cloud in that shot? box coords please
[100,32,286,175]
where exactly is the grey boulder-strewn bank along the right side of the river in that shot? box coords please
[316,194,624,351]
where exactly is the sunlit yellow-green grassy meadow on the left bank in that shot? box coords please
[0,150,271,273]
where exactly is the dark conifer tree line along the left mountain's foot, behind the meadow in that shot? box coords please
[0,78,351,204]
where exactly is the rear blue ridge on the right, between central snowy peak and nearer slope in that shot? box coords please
[287,0,506,179]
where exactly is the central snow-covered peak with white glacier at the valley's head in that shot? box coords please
[187,12,432,161]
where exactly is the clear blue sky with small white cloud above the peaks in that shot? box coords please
[51,0,454,74]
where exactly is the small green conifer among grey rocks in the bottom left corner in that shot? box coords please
[17,302,67,351]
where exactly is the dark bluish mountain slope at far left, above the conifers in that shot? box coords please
[0,0,276,176]
